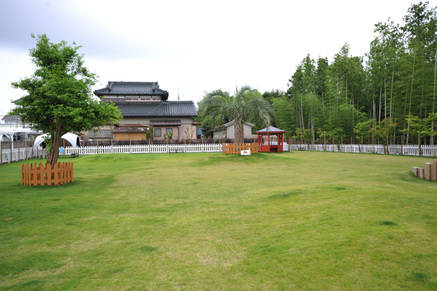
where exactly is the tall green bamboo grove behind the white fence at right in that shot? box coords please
[278,2,437,144]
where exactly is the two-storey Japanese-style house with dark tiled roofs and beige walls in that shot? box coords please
[89,82,198,141]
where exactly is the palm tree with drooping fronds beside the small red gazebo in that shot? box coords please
[201,86,273,143]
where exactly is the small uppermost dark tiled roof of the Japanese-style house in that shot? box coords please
[94,82,168,100]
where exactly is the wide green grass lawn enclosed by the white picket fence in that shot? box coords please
[0,152,437,290]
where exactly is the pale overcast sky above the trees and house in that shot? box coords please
[0,0,416,114]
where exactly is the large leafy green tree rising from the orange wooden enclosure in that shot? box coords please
[9,34,121,166]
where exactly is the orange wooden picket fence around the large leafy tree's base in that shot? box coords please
[21,162,74,186]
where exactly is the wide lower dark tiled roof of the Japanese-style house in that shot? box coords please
[115,101,197,117]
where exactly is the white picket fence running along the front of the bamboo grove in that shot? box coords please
[289,144,437,157]
